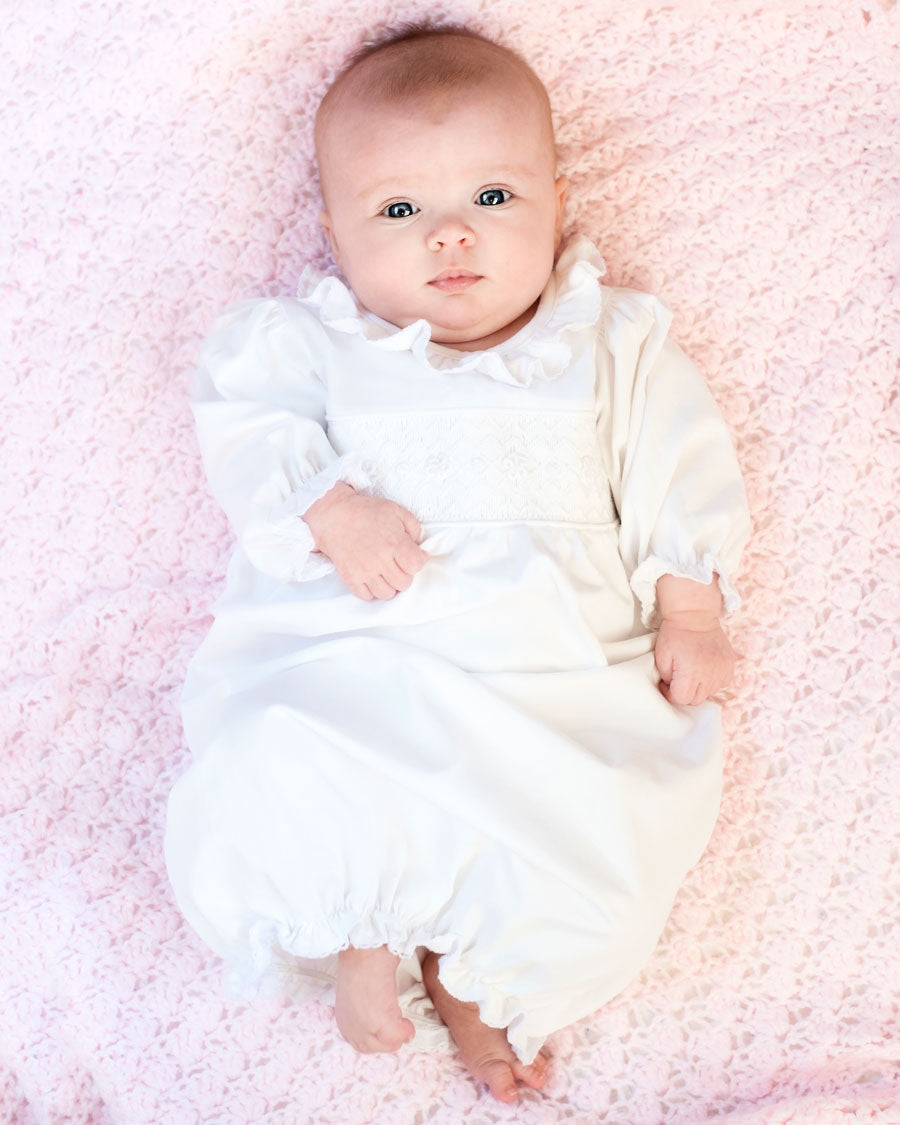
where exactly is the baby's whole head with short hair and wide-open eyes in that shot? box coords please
[316,29,567,350]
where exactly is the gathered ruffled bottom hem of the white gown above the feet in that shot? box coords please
[226,911,545,1063]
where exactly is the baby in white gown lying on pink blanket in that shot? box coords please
[167,28,747,1101]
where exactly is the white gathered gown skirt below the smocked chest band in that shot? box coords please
[167,525,721,1061]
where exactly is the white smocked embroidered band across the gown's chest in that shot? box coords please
[329,411,617,524]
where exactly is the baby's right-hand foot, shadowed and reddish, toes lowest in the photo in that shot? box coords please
[422,953,548,1101]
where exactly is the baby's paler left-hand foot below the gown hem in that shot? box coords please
[334,945,415,1054]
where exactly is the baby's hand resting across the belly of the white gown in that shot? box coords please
[304,483,428,602]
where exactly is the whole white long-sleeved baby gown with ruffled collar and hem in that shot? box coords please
[165,240,748,1061]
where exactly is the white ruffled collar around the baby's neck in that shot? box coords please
[297,237,606,387]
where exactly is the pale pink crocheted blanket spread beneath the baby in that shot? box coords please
[0,0,900,1125]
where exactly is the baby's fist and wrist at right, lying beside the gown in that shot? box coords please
[655,574,735,705]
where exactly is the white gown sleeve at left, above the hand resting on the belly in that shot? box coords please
[194,299,369,582]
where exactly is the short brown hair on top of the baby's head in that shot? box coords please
[316,23,552,148]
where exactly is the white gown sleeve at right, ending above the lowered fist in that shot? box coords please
[599,289,749,628]
